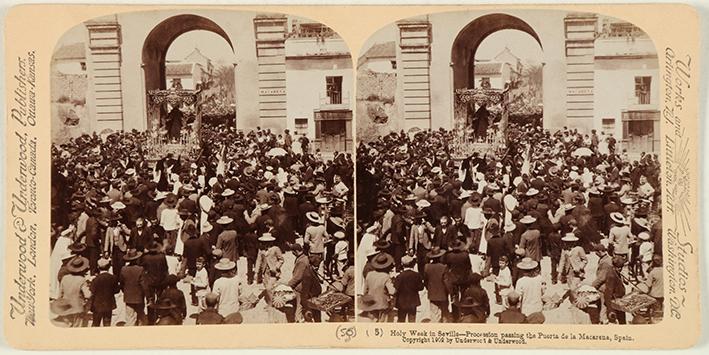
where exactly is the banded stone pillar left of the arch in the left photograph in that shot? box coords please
[86,15,124,132]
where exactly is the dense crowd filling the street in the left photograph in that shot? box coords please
[47,124,354,327]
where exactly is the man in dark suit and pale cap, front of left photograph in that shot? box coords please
[91,259,120,327]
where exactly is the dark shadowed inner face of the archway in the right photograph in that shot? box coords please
[451,13,544,136]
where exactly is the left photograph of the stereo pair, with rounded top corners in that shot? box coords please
[47,10,355,327]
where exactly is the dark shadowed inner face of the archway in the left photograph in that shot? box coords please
[142,14,234,128]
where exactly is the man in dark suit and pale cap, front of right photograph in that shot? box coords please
[394,255,423,323]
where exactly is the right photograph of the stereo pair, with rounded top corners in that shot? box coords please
[355,10,664,325]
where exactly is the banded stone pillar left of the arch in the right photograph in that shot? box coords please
[397,17,431,130]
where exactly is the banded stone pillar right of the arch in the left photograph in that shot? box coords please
[254,15,288,132]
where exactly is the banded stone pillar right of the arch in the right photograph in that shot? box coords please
[564,13,598,133]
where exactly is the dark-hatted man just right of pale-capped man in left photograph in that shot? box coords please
[119,249,146,326]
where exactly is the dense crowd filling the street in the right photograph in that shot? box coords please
[356,124,663,324]
